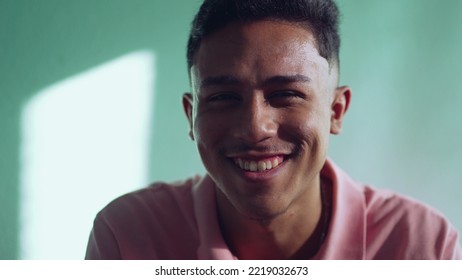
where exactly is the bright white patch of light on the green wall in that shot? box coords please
[20,51,154,259]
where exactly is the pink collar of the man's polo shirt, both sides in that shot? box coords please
[193,159,366,260]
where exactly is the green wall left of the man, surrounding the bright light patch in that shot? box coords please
[0,0,202,259]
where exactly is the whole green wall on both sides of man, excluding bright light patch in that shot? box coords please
[0,0,462,259]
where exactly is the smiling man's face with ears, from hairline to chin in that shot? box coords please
[183,21,349,219]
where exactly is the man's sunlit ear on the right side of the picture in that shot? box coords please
[330,86,351,134]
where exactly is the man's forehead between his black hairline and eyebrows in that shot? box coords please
[191,20,329,88]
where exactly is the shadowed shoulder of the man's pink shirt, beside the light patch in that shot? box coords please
[87,176,200,259]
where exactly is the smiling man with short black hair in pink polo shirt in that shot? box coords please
[86,0,461,259]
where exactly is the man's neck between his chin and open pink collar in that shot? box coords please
[217,176,328,259]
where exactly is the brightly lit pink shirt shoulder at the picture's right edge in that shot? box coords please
[363,186,460,259]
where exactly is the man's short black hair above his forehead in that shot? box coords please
[187,0,340,69]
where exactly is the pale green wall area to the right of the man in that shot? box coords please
[331,0,462,230]
